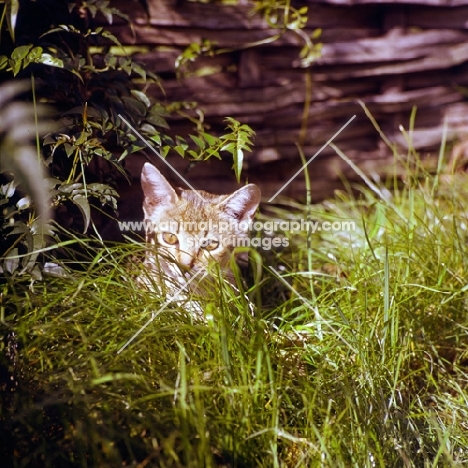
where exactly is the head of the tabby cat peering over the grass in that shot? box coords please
[141,163,261,282]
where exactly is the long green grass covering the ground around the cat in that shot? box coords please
[0,152,468,468]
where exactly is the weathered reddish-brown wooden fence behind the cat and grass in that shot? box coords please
[104,0,468,200]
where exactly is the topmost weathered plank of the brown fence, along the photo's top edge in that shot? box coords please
[109,0,468,34]
